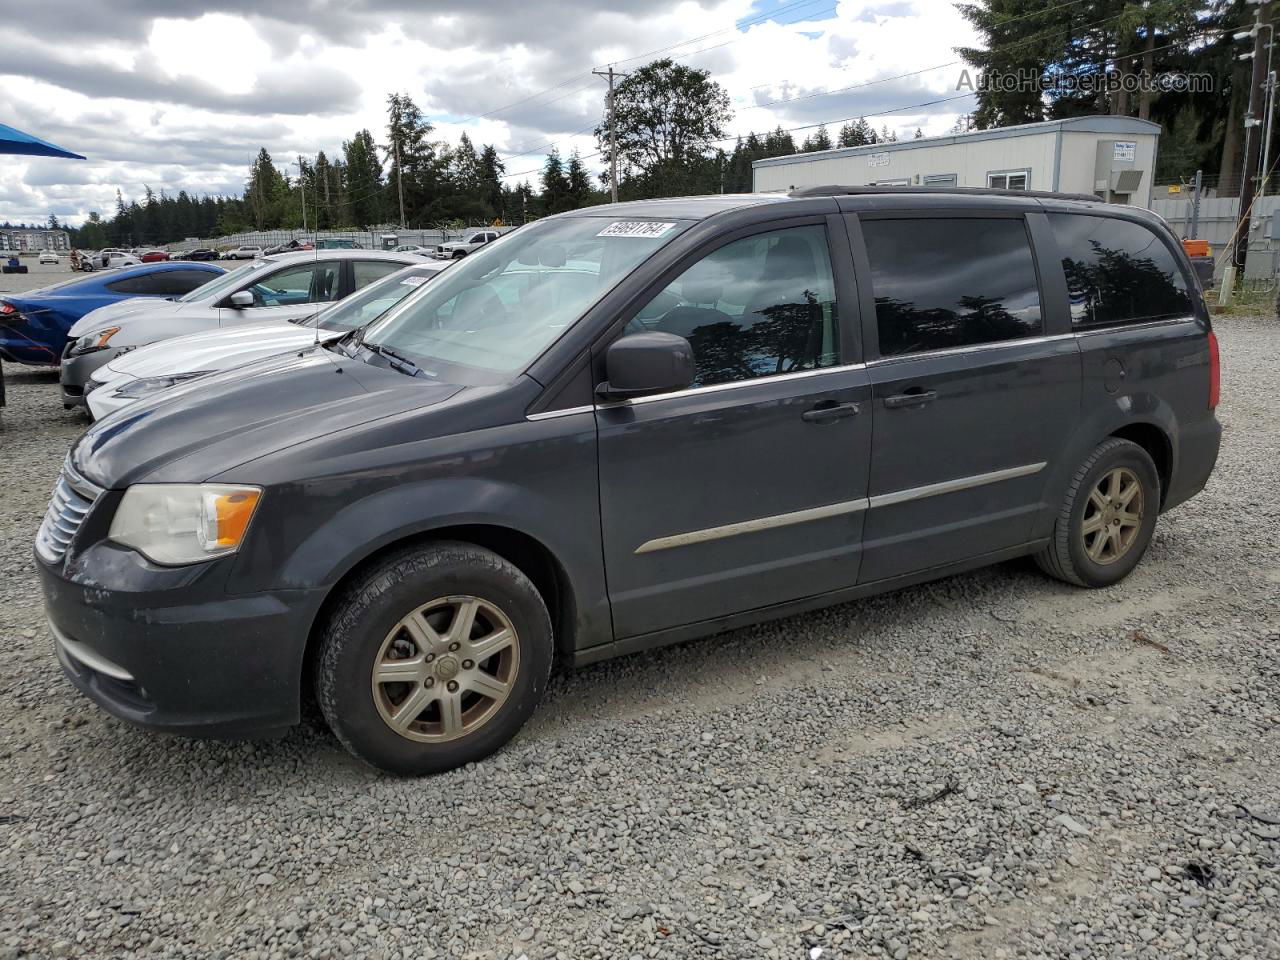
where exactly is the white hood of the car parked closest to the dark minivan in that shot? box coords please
[97,320,325,380]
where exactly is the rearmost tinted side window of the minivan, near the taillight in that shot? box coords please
[1048,214,1192,326]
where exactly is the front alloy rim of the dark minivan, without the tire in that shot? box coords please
[371,596,520,744]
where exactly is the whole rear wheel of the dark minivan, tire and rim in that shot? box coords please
[1036,436,1160,586]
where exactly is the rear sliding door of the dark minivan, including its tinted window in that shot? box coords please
[849,207,1080,582]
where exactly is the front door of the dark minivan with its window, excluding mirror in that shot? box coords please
[595,216,872,639]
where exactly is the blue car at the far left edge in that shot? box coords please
[0,261,225,366]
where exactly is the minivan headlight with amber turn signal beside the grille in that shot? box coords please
[108,484,262,566]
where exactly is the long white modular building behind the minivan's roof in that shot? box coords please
[751,115,1160,207]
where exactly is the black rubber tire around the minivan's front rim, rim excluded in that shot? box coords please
[315,541,554,777]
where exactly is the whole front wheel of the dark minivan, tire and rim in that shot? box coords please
[316,543,553,776]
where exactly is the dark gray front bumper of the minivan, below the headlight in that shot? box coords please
[36,543,323,737]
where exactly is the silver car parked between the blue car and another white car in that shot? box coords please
[60,250,422,406]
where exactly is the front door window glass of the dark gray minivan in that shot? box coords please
[632,224,840,387]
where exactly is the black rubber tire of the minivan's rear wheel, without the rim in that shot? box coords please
[1036,436,1161,588]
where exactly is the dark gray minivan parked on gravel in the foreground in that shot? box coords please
[36,187,1220,774]
